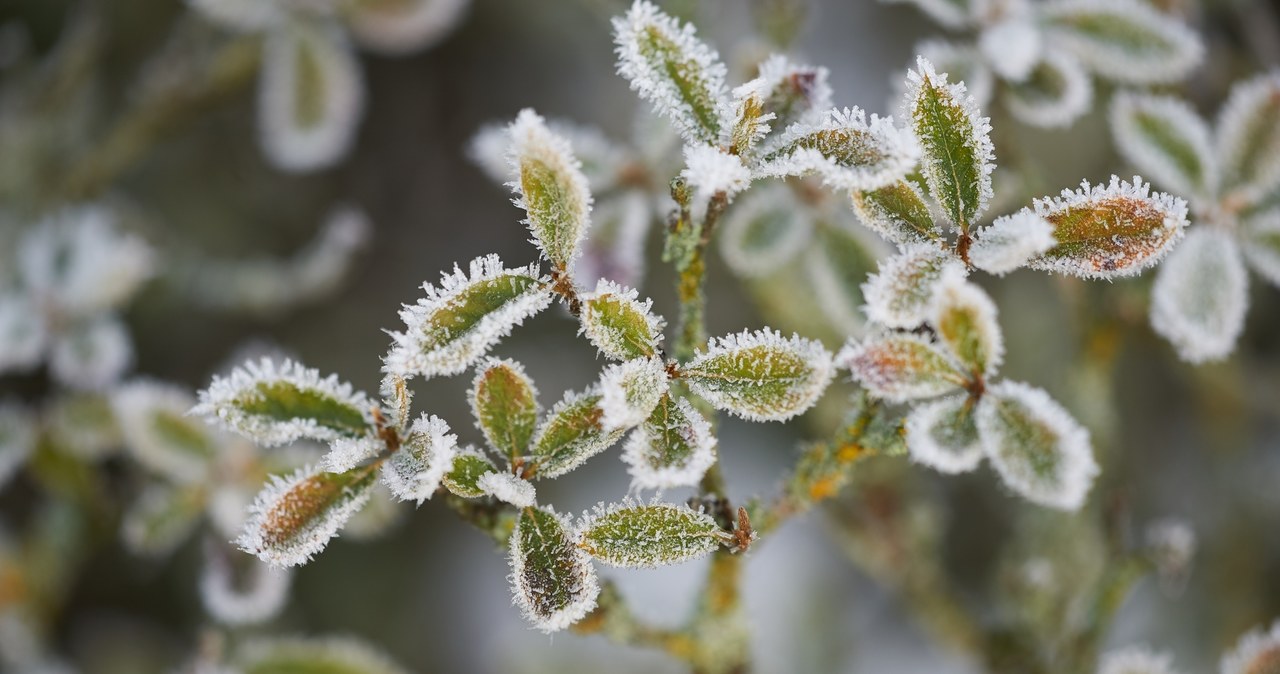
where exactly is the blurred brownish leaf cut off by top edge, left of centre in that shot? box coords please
[344,0,471,55]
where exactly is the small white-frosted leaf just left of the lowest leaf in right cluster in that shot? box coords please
[905,394,982,473]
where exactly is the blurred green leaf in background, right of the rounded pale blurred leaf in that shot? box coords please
[801,225,884,335]
